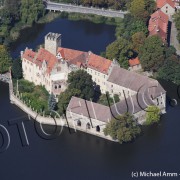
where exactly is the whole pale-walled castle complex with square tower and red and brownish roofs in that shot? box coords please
[21,32,166,135]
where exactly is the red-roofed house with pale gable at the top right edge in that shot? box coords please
[156,0,176,18]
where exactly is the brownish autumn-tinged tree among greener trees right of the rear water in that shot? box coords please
[132,32,146,53]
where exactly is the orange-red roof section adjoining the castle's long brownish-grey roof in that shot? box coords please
[87,52,112,74]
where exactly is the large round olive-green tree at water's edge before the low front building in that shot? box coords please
[104,113,141,144]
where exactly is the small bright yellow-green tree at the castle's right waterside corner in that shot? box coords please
[146,106,160,125]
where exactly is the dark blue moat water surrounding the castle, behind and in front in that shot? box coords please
[0,19,180,180]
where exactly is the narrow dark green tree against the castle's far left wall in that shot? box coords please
[12,58,23,79]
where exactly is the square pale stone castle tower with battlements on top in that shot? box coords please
[45,32,61,55]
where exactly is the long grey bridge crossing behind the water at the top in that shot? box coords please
[44,0,127,18]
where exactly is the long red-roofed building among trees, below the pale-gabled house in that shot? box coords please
[148,9,169,43]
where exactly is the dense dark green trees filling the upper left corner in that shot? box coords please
[0,0,45,45]
